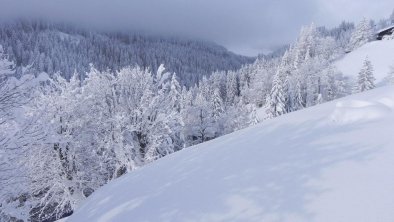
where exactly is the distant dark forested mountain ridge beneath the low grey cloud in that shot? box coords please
[0,20,255,86]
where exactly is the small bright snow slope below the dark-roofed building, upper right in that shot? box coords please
[335,40,394,83]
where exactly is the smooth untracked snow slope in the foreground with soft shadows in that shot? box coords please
[67,87,394,222]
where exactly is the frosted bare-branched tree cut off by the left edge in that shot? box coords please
[0,57,50,221]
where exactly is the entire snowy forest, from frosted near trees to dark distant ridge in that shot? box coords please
[0,10,394,221]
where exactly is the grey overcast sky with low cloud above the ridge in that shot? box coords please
[0,0,394,55]
